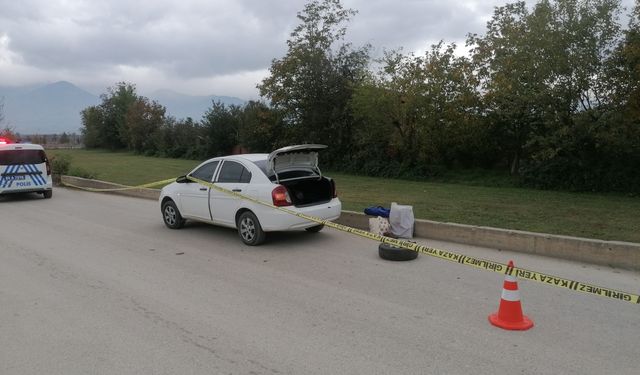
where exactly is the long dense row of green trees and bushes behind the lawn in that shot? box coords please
[82,0,640,193]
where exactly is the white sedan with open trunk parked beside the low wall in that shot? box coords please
[159,145,342,245]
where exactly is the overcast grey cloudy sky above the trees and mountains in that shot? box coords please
[0,0,634,99]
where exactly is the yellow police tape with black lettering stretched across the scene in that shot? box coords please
[64,176,640,304]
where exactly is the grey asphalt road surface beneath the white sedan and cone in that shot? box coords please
[0,188,640,375]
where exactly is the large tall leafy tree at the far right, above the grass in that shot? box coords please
[480,0,638,191]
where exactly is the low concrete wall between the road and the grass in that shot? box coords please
[62,176,640,270]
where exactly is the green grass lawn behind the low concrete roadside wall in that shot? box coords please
[47,150,640,243]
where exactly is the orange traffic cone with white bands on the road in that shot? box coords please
[489,260,533,331]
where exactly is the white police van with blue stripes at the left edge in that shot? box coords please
[0,138,53,198]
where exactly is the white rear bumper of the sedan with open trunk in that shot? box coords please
[255,198,342,232]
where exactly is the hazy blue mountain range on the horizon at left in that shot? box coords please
[0,81,245,134]
